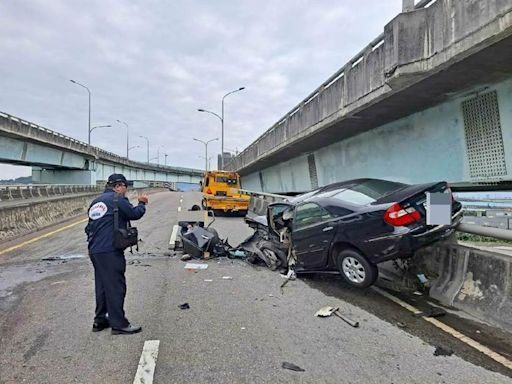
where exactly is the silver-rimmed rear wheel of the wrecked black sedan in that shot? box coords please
[336,249,378,288]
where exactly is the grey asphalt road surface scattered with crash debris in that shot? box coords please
[0,192,512,383]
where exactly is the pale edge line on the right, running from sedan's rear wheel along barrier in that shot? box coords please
[372,287,512,369]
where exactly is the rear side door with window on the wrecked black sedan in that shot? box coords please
[292,202,336,270]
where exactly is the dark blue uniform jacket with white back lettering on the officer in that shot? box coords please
[85,189,146,253]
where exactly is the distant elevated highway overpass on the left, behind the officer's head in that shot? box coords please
[0,112,202,185]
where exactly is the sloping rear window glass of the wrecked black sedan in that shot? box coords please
[315,179,407,205]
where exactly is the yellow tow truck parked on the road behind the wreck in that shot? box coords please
[200,171,251,214]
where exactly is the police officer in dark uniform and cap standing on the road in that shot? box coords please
[85,174,148,335]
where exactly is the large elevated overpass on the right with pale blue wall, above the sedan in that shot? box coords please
[228,0,512,192]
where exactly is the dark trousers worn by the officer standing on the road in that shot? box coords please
[89,251,130,328]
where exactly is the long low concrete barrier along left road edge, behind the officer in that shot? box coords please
[0,188,167,243]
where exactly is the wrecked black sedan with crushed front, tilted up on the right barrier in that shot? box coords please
[241,179,462,287]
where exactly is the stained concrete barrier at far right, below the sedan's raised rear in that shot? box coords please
[411,242,512,331]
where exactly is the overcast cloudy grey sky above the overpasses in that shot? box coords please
[0,0,402,179]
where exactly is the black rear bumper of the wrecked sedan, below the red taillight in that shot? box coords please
[360,210,462,264]
